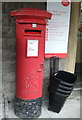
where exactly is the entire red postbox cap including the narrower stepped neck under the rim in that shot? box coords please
[10,8,52,24]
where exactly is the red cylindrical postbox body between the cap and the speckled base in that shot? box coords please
[16,23,45,99]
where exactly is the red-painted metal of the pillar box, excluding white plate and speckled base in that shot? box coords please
[10,8,51,100]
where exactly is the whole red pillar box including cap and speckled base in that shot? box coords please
[10,8,51,118]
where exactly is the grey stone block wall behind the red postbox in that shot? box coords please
[2,2,65,101]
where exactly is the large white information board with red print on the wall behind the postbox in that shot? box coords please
[45,0,70,57]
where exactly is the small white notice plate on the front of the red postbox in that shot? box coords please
[27,40,38,57]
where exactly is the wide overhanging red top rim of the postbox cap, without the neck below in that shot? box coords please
[10,8,52,19]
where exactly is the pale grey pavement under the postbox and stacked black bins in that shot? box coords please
[3,90,81,118]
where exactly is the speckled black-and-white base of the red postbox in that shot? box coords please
[14,97,42,118]
